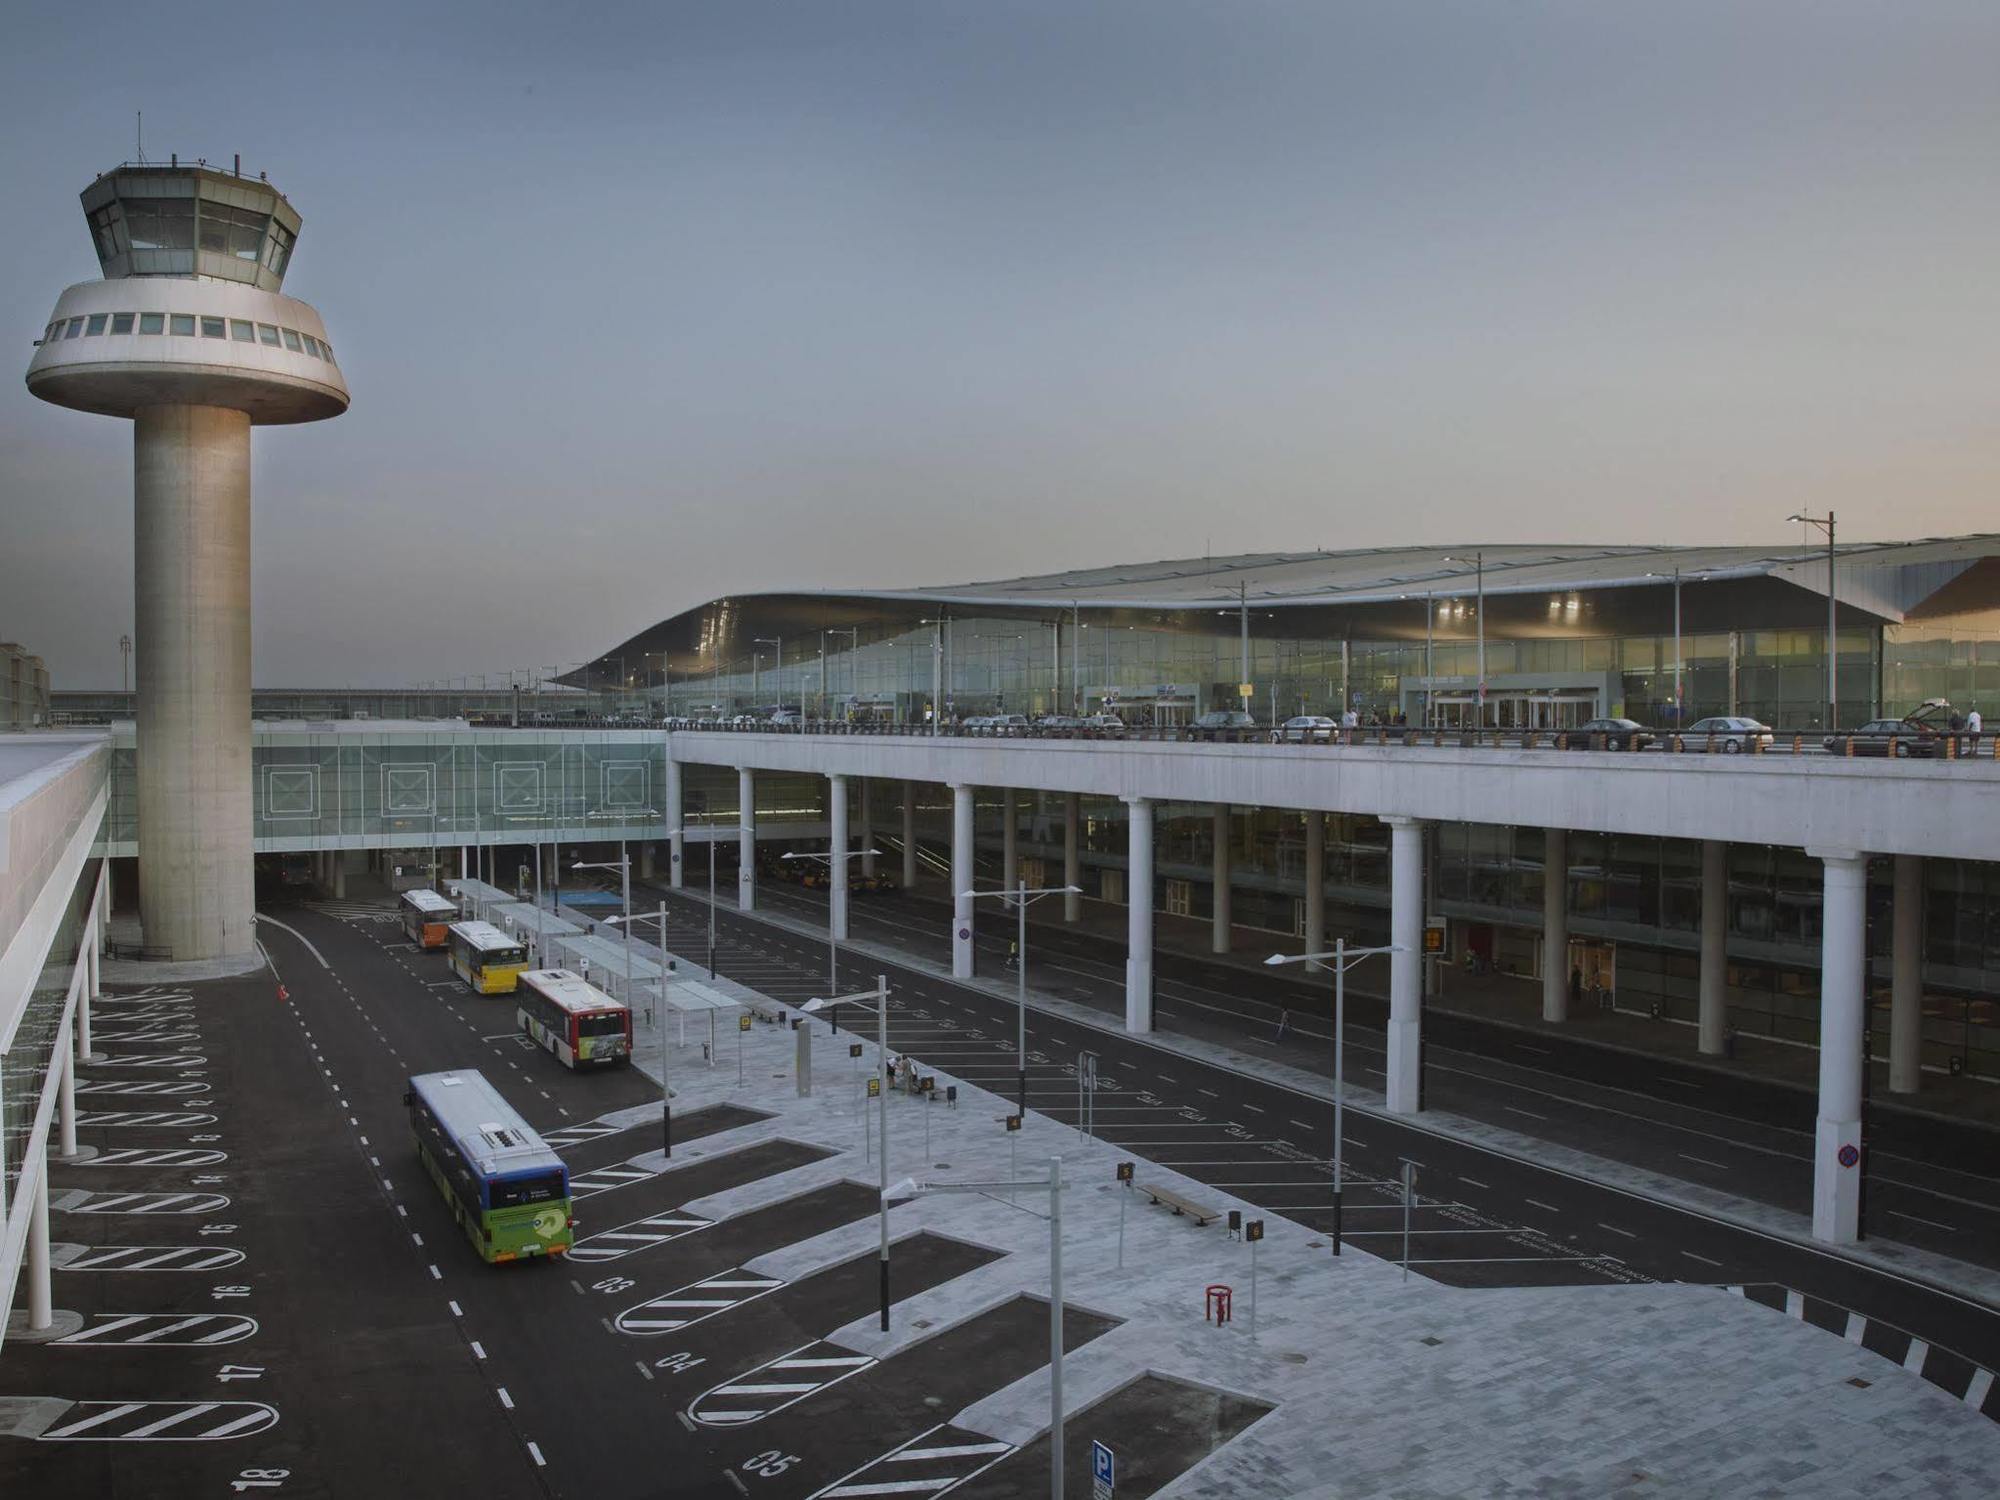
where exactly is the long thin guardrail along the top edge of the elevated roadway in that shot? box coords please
[648,720,2000,760]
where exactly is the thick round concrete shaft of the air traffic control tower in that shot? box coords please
[132,406,256,960]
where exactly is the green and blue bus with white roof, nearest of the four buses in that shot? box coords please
[402,1068,576,1264]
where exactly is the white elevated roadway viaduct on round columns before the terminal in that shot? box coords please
[666,730,2000,1244]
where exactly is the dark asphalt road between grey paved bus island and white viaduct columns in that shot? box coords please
[628,868,2000,1410]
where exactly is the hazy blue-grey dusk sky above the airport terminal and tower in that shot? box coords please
[0,0,2000,688]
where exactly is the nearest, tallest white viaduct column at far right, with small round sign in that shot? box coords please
[1806,850,1868,1244]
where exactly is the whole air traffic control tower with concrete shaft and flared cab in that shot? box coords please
[28,160,348,960]
